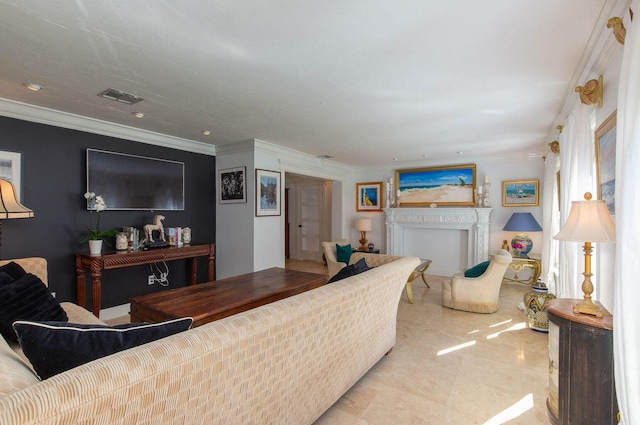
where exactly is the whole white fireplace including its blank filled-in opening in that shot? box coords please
[384,208,492,276]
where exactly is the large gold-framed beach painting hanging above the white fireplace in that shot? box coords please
[396,164,476,207]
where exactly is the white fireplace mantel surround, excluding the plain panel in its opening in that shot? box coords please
[384,207,492,267]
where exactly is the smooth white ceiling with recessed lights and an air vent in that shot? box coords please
[0,0,614,165]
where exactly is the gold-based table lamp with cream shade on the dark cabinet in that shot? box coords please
[553,192,616,317]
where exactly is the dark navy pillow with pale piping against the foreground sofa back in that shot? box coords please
[13,317,193,379]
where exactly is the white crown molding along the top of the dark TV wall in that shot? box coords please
[0,98,216,156]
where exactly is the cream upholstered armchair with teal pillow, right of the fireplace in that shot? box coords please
[442,249,512,313]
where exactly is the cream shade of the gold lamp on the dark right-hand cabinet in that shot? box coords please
[553,196,616,242]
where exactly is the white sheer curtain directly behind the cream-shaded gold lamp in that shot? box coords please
[552,101,595,298]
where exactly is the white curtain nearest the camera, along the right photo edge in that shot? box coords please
[613,0,640,425]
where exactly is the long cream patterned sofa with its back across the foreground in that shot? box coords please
[0,254,419,425]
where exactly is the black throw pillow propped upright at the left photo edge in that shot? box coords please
[0,273,68,342]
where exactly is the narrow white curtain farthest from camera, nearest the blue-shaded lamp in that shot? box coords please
[541,152,560,294]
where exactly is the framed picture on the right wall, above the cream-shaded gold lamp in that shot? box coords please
[595,111,617,215]
